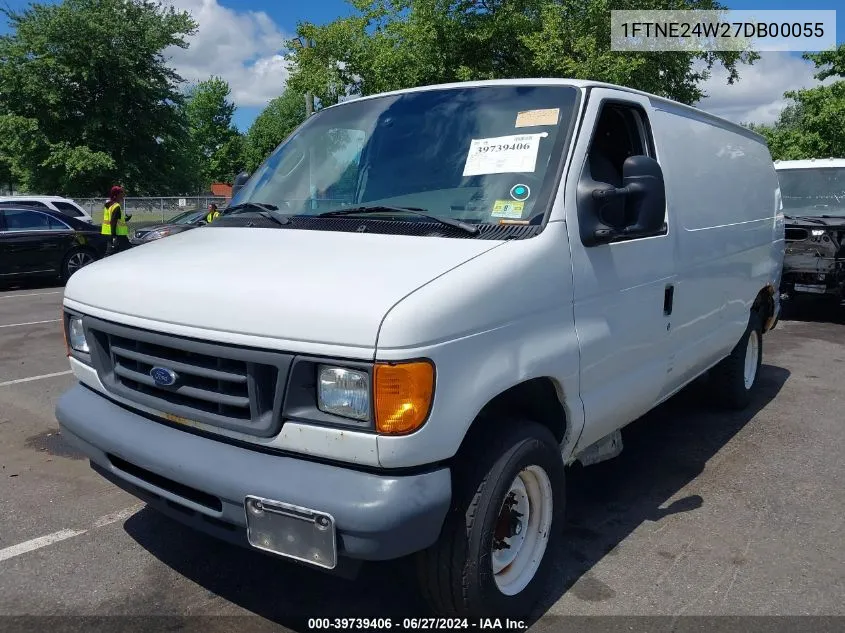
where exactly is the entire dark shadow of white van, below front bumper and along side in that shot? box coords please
[122,365,789,631]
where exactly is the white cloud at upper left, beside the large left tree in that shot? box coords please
[165,0,289,107]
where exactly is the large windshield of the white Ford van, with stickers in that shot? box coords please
[231,85,578,230]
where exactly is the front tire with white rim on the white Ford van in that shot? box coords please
[417,421,565,617]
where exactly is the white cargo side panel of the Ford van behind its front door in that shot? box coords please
[652,100,780,395]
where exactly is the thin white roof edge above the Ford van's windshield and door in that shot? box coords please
[329,77,766,143]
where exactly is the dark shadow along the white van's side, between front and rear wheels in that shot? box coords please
[535,364,790,616]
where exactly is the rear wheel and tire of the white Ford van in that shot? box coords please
[711,312,763,411]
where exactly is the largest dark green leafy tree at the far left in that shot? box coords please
[0,0,196,195]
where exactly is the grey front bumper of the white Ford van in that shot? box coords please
[56,385,451,560]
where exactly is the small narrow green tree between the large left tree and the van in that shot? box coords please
[185,77,243,187]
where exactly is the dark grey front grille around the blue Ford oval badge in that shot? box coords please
[83,317,293,436]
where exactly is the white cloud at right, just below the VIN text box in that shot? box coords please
[697,52,832,123]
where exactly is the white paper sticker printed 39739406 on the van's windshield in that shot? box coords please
[464,132,548,176]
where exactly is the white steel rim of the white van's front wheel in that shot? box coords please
[490,465,554,596]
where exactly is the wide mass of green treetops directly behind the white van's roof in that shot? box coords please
[288,0,758,103]
